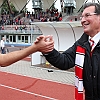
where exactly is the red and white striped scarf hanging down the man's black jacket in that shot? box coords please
[75,46,85,100]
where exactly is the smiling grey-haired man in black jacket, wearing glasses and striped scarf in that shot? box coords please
[35,3,100,100]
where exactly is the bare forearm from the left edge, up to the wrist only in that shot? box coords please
[0,45,37,67]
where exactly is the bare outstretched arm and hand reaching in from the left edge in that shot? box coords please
[0,34,54,67]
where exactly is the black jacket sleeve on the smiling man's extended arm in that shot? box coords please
[44,44,76,70]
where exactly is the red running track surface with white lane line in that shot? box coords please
[0,72,74,100]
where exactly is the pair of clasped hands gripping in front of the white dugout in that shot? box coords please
[34,35,54,53]
